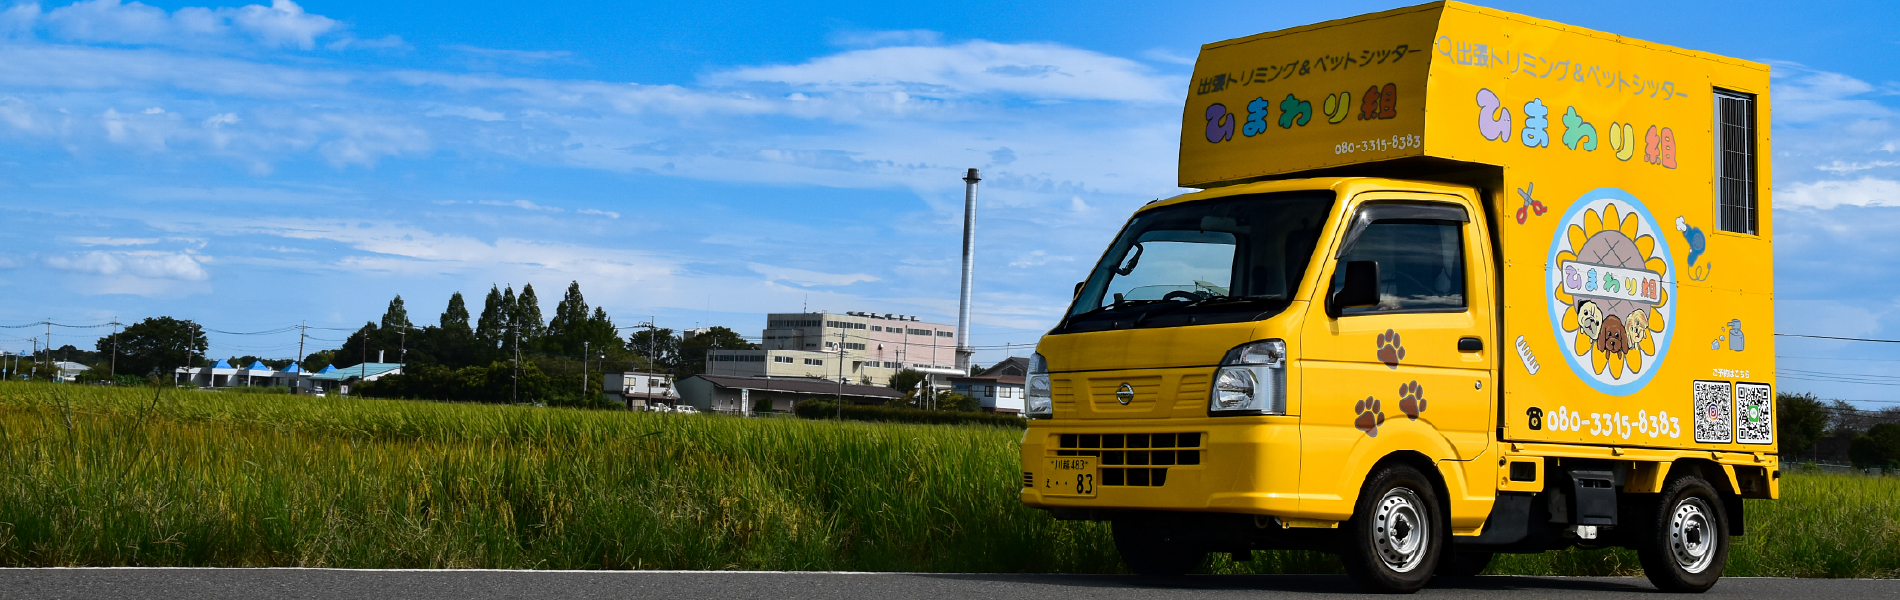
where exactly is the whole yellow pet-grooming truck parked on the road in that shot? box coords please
[1022,2,1780,592]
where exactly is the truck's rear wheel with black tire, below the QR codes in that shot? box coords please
[1636,475,1729,592]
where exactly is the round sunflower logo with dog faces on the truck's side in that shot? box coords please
[1549,188,1676,395]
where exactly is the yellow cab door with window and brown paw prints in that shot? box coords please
[1300,192,1499,513]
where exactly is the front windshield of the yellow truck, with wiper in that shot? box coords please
[1056,192,1334,332]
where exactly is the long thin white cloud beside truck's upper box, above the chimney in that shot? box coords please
[707,42,1180,103]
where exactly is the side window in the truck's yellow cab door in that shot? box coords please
[1332,220,1465,315]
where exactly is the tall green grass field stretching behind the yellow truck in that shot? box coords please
[0,384,1900,577]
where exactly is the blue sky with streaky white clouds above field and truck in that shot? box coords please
[0,0,1900,399]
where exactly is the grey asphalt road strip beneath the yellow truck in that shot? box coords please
[0,570,1900,600]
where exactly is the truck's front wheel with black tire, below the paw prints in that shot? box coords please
[1340,463,1450,594]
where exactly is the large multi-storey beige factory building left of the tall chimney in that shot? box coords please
[707,311,965,387]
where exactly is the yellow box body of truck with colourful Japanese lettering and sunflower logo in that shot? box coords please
[1180,4,1775,452]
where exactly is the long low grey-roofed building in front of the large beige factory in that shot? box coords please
[680,374,901,414]
